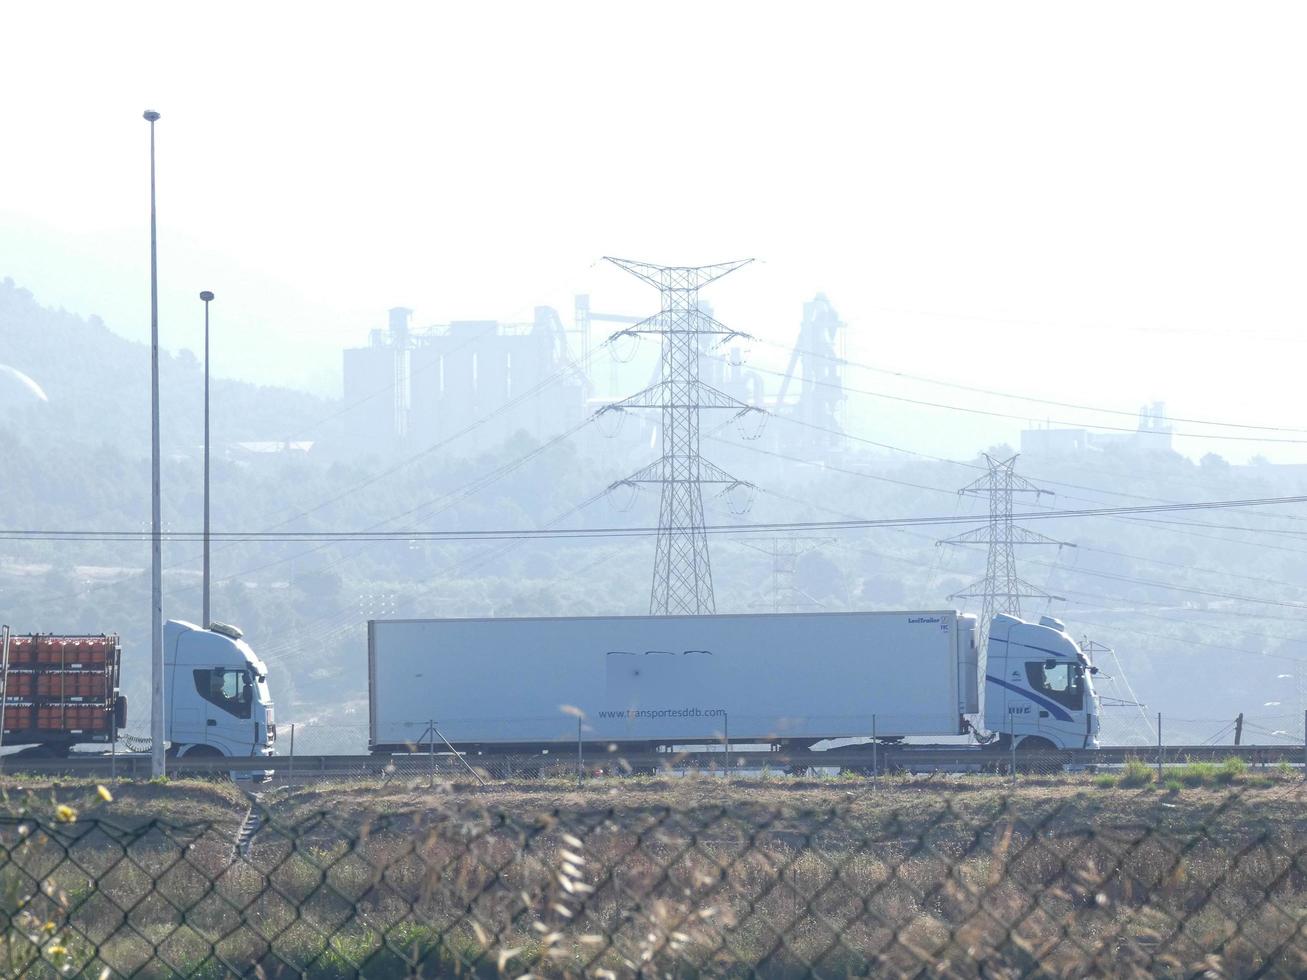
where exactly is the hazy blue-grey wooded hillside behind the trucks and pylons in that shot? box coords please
[0,280,1307,751]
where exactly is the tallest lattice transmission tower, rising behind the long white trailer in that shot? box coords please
[600,256,759,615]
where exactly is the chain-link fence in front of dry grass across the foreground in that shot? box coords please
[0,781,1307,977]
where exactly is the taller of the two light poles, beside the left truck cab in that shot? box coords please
[145,108,165,777]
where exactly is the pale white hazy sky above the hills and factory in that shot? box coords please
[0,3,1307,460]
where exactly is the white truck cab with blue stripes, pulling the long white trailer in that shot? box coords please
[984,614,1100,750]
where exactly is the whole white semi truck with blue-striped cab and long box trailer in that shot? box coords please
[367,610,1099,753]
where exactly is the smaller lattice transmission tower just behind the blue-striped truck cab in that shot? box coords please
[940,453,1067,663]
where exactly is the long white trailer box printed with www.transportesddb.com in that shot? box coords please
[369,610,971,747]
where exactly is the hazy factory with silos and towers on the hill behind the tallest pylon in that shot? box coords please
[341,294,844,459]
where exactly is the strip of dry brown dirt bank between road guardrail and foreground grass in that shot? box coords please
[0,774,1307,836]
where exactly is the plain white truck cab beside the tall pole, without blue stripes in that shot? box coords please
[163,619,277,775]
